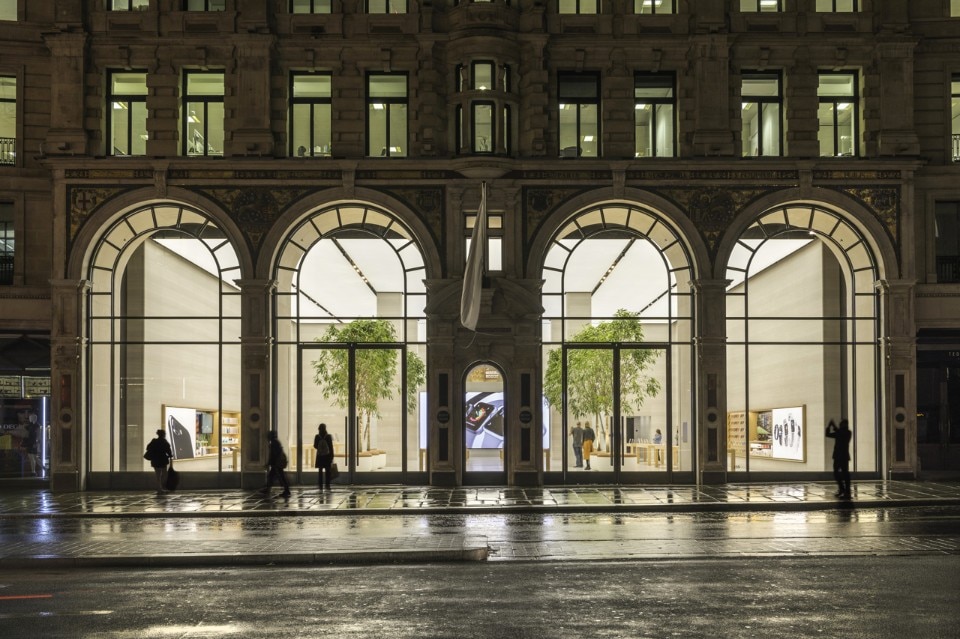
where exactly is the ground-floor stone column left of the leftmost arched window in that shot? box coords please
[50,280,89,492]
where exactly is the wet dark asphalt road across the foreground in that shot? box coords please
[0,555,960,639]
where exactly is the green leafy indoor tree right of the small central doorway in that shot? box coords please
[543,309,660,450]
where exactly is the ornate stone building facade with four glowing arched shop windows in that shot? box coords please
[0,0,960,490]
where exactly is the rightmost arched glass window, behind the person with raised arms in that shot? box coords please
[726,204,881,474]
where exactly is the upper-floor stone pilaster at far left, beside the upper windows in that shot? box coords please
[43,33,87,155]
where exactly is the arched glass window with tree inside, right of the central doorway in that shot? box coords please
[542,203,696,483]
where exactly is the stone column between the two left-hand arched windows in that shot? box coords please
[236,279,275,488]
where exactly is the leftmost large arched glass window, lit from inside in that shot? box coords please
[87,203,242,480]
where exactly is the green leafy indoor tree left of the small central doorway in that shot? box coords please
[313,319,426,450]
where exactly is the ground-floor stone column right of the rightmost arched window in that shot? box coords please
[877,280,917,479]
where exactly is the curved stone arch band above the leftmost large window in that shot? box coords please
[67,187,253,279]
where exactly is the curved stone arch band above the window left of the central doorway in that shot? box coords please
[256,187,442,279]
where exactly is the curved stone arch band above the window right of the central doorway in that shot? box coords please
[527,187,710,277]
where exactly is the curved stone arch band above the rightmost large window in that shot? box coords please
[714,188,900,279]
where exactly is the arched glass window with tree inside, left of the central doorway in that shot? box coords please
[273,203,427,481]
